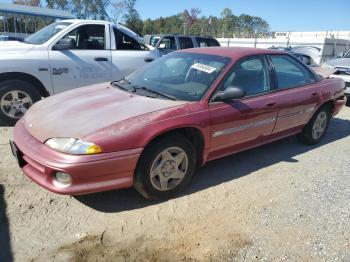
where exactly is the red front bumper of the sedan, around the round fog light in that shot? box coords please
[13,121,142,195]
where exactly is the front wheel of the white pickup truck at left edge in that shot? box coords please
[0,80,41,126]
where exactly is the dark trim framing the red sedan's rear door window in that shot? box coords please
[266,54,322,92]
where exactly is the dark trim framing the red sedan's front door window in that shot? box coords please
[209,54,276,105]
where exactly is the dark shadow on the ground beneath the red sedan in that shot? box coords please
[76,118,350,213]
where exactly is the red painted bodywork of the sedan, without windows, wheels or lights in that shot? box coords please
[14,48,346,195]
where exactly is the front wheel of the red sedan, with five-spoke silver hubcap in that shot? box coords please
[134,135,197,199]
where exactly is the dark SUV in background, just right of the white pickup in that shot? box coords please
[144,34,220,56]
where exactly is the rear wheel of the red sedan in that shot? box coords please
[298,106,331,145]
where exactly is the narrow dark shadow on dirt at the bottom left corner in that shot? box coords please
[0,185,13,262]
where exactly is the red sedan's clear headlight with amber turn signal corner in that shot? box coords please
[45,138,102,155]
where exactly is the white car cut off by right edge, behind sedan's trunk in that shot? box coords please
[322,50,350,99]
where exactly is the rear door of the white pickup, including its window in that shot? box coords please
[111,27,156,80]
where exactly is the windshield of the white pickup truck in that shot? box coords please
[25,22,71,45]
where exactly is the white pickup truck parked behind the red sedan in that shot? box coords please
[0,20,157,125]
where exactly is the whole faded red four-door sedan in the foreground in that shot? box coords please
[11,47,346,199]
